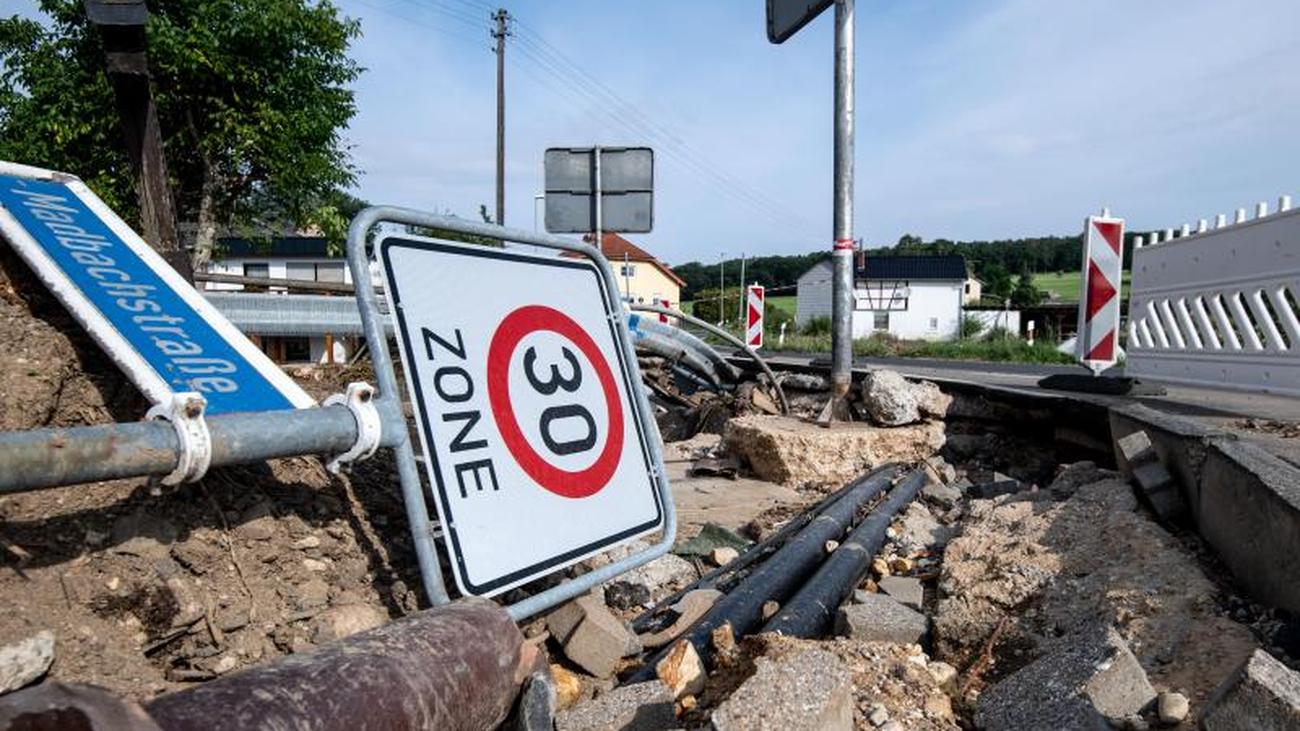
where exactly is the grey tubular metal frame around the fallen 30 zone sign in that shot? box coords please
[347,207,677,619]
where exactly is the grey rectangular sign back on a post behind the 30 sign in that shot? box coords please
[543,147,654,234]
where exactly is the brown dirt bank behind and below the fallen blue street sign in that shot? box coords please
[0,250,423,698]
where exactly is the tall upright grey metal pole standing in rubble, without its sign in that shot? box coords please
[831,0,853,402]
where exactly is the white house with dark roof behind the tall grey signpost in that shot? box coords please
[796,254,969,339]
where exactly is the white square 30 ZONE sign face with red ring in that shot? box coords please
[380,238,663,596]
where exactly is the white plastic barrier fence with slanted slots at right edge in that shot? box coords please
[1125,196,1300,395]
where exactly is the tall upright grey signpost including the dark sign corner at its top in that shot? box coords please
[767,0,853,420]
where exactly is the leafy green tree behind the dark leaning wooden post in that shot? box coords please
[0,0,361,263]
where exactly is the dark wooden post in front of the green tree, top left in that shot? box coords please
[85,0,194,282]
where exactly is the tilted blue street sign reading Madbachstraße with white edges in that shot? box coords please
[0,163,316,415]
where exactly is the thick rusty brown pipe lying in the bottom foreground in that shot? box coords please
[146,598,530,731]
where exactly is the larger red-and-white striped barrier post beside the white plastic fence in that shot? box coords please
[1075,209,1125,375]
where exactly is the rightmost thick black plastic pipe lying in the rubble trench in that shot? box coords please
[763,470,926,637]
